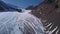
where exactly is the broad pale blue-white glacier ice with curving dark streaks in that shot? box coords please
[0,12,44,34]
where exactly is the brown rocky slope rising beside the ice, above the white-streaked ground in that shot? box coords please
[32,0,60,33]
